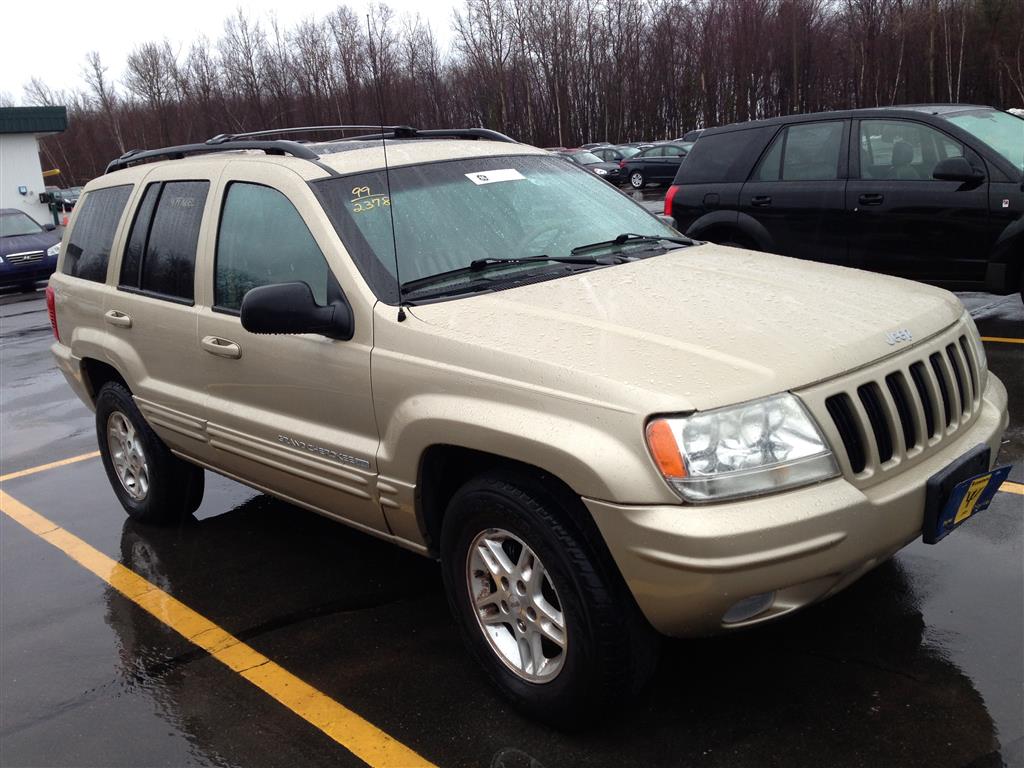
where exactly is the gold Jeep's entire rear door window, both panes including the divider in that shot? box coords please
[121,181,210,303]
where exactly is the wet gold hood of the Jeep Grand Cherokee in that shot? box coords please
[403,245,964,414]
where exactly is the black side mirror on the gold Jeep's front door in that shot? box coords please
[242,283,355,340]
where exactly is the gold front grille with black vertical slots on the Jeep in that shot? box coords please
[799,323,984,484]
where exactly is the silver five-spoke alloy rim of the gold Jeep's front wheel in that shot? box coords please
[466,528,567,683]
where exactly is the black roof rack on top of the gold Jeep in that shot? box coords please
[104,125,518,173]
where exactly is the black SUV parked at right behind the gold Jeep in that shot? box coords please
[665,104,1024,294]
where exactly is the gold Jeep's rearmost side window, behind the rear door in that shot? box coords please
[63,184,132,283]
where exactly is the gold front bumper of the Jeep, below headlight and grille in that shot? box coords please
[584,374,1009,637]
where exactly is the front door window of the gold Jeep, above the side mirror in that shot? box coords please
[214,182,328,309]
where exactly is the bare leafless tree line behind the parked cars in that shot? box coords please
[24,0,1024,183]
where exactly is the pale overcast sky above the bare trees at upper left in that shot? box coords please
[0,0,457,104]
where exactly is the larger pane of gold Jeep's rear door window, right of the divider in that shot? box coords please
[139,181,210,301]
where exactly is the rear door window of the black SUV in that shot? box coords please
[757,121,843,181]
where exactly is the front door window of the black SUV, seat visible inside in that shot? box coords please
[859,120,964,181]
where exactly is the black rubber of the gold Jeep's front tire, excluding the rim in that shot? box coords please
[441,481,605,727]
